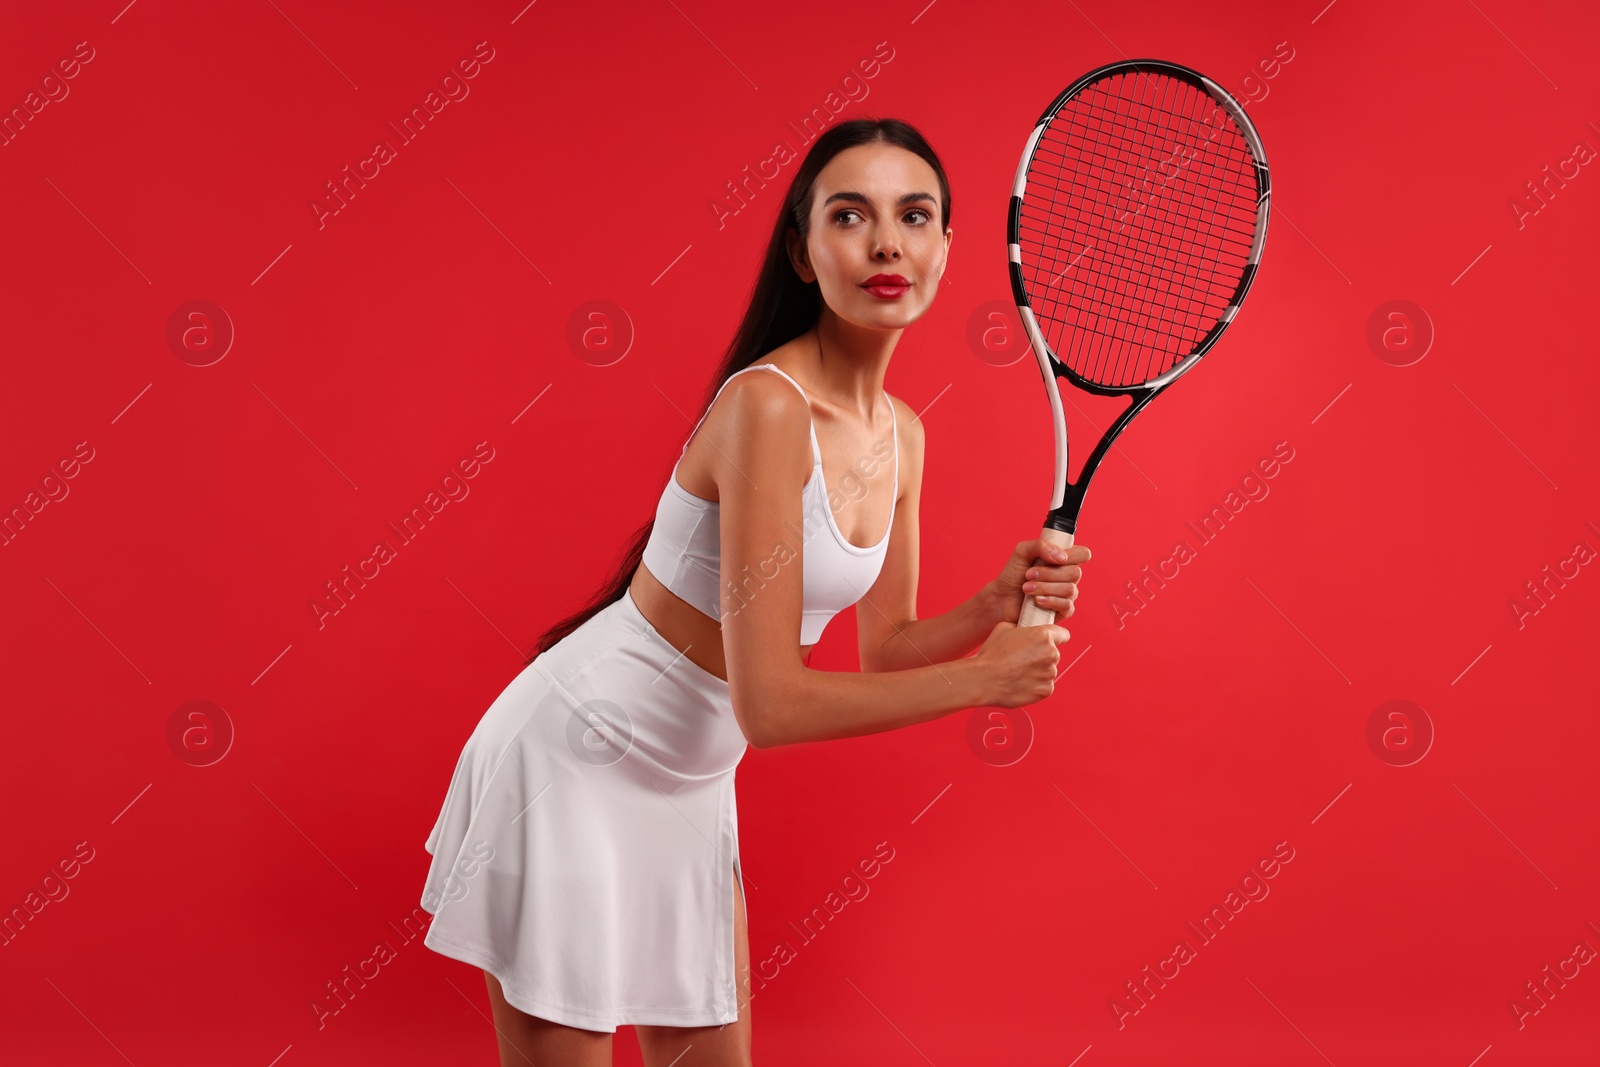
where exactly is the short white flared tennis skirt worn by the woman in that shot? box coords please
[422,593,746,1032]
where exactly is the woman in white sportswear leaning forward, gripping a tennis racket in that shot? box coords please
[422,118,1090,1067]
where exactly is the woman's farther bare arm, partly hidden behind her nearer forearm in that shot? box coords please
[856,400,1016,672]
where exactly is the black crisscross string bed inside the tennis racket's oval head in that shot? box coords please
[1018,65,1259,386]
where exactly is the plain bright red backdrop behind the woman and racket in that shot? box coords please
[0,0,1600,1067]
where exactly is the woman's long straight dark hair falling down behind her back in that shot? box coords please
[525,118,950,664]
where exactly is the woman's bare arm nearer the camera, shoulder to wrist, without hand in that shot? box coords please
[714,374,990,749]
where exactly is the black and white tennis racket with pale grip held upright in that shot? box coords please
[1006,59,1269,625]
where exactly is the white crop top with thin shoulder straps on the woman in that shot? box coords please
[643,363,899,645]
